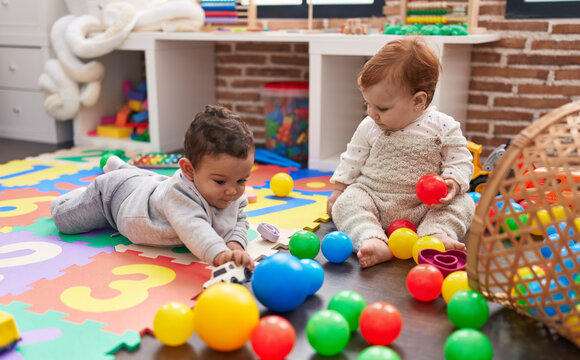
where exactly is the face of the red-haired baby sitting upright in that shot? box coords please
[362,79,425,131]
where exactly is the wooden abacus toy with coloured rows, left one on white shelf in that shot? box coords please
[199,0,258,30]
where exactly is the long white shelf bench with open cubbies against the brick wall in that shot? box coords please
[74,32,500,170]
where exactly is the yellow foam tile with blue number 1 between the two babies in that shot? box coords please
[245,188,329,231]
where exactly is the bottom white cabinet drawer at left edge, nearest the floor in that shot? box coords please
[0,89,72,144]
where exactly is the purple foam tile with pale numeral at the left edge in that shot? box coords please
[0,231,115,297]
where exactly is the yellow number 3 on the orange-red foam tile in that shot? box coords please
[60,264,176,312]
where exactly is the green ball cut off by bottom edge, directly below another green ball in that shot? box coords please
[443,329,493,360]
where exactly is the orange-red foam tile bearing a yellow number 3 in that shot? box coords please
[0,250,211,334]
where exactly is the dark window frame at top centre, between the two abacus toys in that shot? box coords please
[258,0,385,19]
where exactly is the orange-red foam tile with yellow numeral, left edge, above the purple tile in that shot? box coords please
[0,188,60,227]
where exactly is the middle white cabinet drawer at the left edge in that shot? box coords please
[0,46,45,90]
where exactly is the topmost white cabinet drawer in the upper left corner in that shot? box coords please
[0,0,40,28]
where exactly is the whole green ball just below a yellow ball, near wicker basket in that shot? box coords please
[447,290,489,329]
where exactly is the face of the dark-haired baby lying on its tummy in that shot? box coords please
[192,152,254,209]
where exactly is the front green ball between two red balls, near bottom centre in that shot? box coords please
[306,310,350,356]
